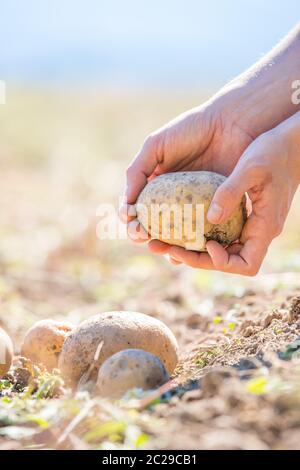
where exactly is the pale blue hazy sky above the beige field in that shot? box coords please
[0,0,300,87]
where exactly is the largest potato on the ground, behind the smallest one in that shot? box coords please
[58,311,178,386]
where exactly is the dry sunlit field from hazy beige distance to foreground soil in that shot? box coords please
[0,88,300,449]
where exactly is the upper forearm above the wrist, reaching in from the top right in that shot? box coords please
[214,23,300,138]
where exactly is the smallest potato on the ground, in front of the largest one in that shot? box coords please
[97,349,169,398]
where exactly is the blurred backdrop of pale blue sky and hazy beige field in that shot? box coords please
[0,0,300,346]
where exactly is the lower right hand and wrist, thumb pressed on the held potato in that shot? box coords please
[165,113,300,276]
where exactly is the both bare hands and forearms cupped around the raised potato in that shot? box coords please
[121,25,300,275]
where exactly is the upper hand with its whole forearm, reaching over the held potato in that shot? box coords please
[121,25,300,237]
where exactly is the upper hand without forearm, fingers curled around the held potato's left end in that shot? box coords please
[121,99,253,248]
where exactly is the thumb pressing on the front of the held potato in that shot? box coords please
[207,165,253,224]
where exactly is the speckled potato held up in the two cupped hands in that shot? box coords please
[136,171,246,251]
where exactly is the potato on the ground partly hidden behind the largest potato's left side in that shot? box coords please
[21,320,73,371]
